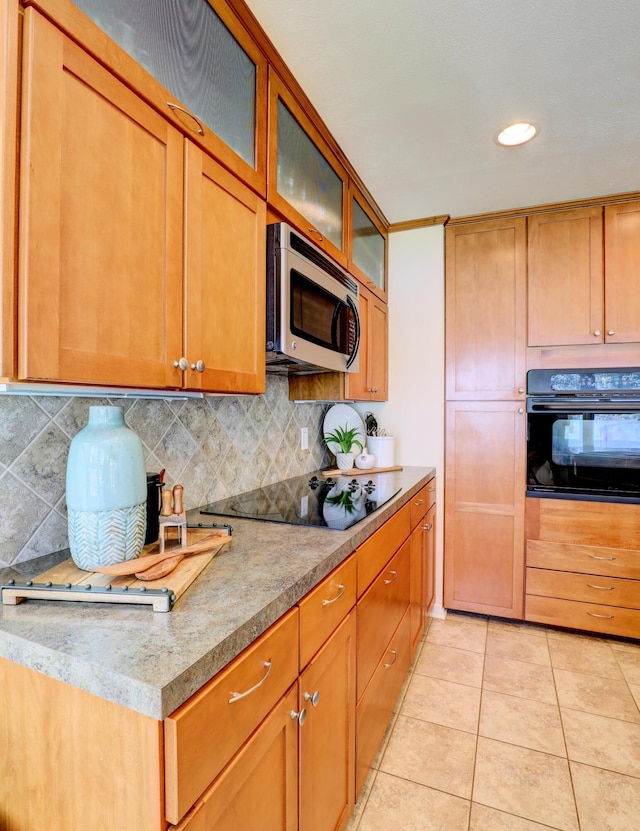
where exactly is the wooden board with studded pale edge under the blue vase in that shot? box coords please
[0,528,230,612]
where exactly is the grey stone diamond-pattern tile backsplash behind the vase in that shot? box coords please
[0,376,333,566]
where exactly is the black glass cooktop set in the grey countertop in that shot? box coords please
[200,471,402,531]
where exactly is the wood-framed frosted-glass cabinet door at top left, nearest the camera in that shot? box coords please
[27,0,267,196]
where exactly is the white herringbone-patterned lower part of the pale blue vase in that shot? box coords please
[68,502,147,571]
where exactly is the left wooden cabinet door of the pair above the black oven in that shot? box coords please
[528,207,604,346]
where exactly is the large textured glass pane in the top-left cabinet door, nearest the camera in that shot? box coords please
[73,0,256,168]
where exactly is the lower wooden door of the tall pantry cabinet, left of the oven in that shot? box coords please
[444,401,526,618]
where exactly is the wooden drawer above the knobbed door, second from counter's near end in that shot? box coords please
[298,554,356,669]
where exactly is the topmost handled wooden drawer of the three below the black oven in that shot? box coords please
[527,540,640,580]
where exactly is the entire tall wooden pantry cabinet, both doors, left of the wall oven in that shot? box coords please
[444,218,526,618]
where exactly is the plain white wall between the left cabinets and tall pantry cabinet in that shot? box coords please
[356,225,444,617]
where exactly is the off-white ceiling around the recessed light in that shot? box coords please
[247,0,640,223]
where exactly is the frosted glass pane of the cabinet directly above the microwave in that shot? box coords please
[277,99,344,251]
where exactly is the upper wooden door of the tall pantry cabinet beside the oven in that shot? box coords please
[445,217,526,400]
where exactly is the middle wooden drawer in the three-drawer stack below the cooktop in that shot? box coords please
[356,538,411,699]
